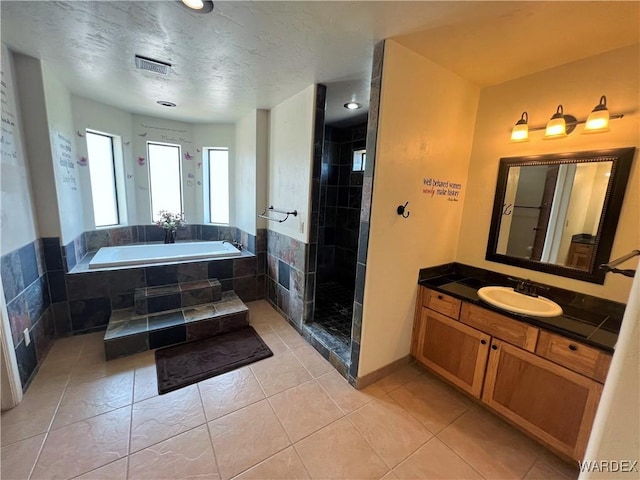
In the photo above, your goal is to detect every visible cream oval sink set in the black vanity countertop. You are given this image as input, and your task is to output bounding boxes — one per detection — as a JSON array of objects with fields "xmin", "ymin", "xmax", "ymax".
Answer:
[{"xmin": 478, "ymin": 287, "xmax": 562, "ymax": 317}]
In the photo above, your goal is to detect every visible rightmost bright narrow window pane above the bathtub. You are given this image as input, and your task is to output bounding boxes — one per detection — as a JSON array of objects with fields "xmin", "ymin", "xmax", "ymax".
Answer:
[{"xmin": 205, "ymin": 148, "xmax": 229, "ymax": 223}]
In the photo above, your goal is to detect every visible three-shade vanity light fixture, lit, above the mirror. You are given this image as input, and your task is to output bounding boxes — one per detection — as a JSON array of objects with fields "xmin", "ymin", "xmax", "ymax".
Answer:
[{"xmin": 511, "ymin": 95, "xmax": 624, "ymax": 142}]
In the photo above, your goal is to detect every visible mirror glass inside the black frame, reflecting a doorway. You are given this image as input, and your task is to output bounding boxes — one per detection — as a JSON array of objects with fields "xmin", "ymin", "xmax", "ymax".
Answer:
[{"xmin": 498, "ymin": 161, "xmax": 612, "ymax": 269}]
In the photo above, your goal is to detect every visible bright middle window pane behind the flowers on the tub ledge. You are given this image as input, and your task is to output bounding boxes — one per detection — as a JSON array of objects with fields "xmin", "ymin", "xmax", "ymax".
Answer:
[{"xmin": 147, "ymin": 142, "xmax": 183, "ymax": 222}]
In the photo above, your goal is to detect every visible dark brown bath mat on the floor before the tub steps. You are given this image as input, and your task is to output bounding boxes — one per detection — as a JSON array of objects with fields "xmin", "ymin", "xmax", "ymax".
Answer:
[{"xmin": 155, "ymin": 327, "xmax": 273, "ymax": 395}]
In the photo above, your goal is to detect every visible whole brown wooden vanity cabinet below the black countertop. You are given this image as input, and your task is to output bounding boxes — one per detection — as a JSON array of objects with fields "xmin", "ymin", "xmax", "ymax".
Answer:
[{"xmin": 412, "ymin": 287, "xmax": 611, "ymax": 460}]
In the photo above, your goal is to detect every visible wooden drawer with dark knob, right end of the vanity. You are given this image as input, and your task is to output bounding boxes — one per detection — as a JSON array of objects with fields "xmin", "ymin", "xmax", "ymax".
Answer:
[{"xmin": 536, "ymin": 331, "xmax": 611, "ymax": 383}]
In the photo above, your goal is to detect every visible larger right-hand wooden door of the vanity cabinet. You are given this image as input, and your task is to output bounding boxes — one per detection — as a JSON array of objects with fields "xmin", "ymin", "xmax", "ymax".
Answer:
[{"xmin": 482, "ymin": 339, "xmax": 602, "ymax": 460}]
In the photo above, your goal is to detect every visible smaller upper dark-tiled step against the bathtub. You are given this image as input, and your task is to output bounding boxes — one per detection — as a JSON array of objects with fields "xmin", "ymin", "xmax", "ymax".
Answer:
[{"xmin": 133, "ymin": 278, "xmax": 222, "ymax": 315}]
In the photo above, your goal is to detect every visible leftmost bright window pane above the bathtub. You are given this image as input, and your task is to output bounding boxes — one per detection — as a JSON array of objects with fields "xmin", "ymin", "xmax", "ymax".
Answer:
[{"xmin": 86, "ymin": 130, "xmax": 120, "ymax": 227}]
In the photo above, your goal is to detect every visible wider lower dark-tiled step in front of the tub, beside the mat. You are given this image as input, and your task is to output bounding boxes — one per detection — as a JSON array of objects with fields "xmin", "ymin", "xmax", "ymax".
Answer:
[{"xmin": 104, "ymin": 291, "xmax": 249, "ymax": 360}]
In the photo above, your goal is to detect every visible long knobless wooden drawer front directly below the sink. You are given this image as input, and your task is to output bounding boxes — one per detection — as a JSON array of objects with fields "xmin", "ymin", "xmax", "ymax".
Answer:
[{"xmin": 460, "ymin": 303, "xmax": 538, "ymax": 352}]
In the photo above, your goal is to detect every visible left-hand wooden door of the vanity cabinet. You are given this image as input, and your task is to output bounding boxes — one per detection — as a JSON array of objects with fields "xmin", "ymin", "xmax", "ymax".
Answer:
[{"xmin": 415, "ymin": 308, "xmax": 491, "ymax": 398}]
